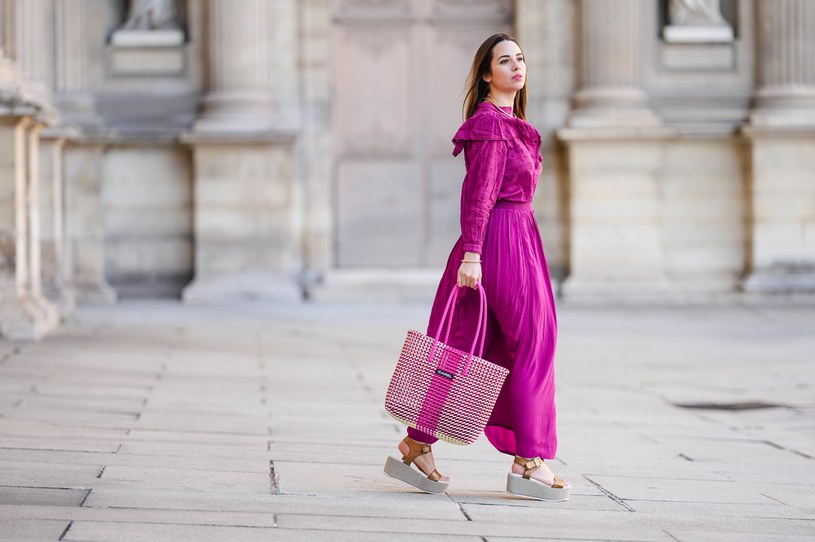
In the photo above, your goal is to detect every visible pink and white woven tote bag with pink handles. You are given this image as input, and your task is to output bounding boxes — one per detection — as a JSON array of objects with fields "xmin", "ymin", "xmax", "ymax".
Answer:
[{"xmin": 385, "ymin": 283, "xmax": 509, "ymax": 445}]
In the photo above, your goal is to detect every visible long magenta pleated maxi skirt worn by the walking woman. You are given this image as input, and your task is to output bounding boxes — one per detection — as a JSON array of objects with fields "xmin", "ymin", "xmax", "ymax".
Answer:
[{"xmin": 408, "ymin": 201, "xmax": 557, "ymax": 459}]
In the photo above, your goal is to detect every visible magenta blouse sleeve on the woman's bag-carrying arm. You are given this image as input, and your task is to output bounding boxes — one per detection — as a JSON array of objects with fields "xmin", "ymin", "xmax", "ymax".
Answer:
[{"xmin": 453, "ymin": 113, "xmax": 508, "ymax": 254}]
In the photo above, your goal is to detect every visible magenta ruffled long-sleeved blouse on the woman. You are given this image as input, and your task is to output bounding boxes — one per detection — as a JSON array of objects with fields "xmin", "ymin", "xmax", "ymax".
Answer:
[{"xmin": 453, "ymin": 102, "xmax": 543, "ymax": 254}]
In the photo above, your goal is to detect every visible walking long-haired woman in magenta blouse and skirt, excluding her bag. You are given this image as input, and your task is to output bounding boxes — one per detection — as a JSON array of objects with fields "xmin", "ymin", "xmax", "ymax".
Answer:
[{"xmin": 386, "ymin": 34, "xmax": 571, "ymax": 500}]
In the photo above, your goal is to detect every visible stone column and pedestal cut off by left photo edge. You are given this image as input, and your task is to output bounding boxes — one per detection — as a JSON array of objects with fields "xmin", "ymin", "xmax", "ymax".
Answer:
[{"xmin": 0, "ymin": 0, "xmax": 57, "ymax": 340}]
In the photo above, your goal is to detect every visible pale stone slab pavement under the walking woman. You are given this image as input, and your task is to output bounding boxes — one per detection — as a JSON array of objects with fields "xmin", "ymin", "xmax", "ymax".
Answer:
[{"xmin": 0, "ymin": 302, "xmax": 815, "ymax": 542}]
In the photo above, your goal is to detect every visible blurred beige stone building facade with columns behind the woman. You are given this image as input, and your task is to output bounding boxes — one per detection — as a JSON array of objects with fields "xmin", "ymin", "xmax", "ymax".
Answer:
[{"xmin": 0, "ymin": 0, "xmax": 815, "ymax": 339}]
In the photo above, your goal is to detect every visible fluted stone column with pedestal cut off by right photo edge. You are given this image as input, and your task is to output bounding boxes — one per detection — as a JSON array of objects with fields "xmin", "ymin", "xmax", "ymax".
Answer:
[{"xmin": 743, "ymin": 0, "xmax": 815, "ymax": 293}]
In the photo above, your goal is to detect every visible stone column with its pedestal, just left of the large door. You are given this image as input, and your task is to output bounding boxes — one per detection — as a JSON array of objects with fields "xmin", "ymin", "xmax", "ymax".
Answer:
[{"xmin": 183, "ymin": 0, "xmax": 300, "ymax": 302}]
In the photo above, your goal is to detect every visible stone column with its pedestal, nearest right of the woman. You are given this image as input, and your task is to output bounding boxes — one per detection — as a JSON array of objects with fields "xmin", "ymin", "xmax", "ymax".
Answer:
[{"xmin": 558, "ymin": 0, "xmax": 672, "ymax": 300}]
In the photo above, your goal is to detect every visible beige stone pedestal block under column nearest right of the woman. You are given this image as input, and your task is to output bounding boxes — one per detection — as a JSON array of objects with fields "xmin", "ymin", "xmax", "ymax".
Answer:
[{"xmin": 563, "ymin": 135, "xmax": 669, "ymax": 298}]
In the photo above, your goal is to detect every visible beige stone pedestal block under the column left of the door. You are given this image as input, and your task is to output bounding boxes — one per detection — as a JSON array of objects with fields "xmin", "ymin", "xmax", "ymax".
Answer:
[{"xmin": 184, "ymin": 144, "xmax": 299, "ymax": 302}]
